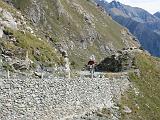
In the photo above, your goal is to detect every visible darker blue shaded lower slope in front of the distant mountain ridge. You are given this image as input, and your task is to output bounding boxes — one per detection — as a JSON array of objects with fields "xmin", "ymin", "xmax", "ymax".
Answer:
[{"xmin": 111, "ymin": 16, "xmax": 160, "ymax": 56}]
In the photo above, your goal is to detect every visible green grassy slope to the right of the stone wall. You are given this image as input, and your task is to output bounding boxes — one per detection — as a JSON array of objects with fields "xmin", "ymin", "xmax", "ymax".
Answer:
[{"xmin": 122, "ymin": 54, "xmax": 160, "ymax": 120}]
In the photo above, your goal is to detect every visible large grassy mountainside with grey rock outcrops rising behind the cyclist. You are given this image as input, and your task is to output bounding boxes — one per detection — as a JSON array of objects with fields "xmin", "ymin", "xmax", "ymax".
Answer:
[{"xmin": 1, "ymin": 0, "xmax": 139, "ymax": 68}]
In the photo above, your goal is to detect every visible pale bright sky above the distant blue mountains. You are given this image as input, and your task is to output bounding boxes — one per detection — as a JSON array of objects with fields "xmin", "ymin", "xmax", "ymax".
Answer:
[{"xmin": 106, "ymin": 0, "xmax": 160, "ymax": 14}]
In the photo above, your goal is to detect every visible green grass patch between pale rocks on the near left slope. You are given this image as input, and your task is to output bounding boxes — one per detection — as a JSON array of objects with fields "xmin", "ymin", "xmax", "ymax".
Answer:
[{"xmin": 1, "ymin": 29, "xmax": 59, "ymax": 65}]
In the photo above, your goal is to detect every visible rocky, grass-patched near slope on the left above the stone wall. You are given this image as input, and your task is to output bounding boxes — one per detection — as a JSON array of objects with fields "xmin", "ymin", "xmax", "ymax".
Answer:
[{"xmin": 0, "ymin": 1, "xmax": 59, "ymax": 70}]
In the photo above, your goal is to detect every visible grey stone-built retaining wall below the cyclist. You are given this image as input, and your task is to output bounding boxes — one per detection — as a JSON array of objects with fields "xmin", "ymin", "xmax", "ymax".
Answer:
[{"xmin": 0, "ymin": 71, "xmax": 130, "ymax": 120}]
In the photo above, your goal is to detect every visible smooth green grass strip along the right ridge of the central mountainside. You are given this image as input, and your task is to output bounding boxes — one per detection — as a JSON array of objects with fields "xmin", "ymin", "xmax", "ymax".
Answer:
[{"xmin": 78, "ymin": 0, "xmax": 124, "ymax": 49}]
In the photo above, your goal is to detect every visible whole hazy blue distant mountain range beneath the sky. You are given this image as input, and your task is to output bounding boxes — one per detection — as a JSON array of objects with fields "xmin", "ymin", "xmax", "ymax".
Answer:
[{"xmin": 96, "ymin": 0, "xmax": 160, "ymax": 56}]
